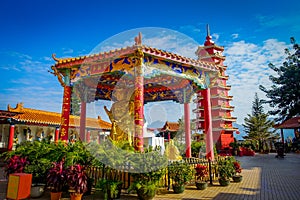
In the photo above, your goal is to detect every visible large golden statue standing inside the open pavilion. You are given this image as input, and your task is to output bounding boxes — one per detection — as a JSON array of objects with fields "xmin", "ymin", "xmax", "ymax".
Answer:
[{"xmin": 104, "ymin": 88, "xmax": 134, "ymax": 144}]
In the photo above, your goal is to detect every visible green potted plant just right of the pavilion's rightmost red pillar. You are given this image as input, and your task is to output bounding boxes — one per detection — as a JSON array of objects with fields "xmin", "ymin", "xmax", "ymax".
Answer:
[{"xmin": 217, "ymin": 157, "xmax": 235, "ymax": 186}]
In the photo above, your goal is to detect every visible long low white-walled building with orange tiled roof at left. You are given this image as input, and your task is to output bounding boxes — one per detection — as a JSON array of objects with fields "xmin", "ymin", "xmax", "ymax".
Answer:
[{"xmin": 0, "ymin": 103, "xmax": 111, "ymax": 151}]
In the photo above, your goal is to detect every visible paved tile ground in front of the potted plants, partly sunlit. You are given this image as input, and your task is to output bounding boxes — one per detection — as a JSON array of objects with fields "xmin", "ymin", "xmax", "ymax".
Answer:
[{"xmin": 0, "ymin": 153, "xmax": 300, "ymax": 200}]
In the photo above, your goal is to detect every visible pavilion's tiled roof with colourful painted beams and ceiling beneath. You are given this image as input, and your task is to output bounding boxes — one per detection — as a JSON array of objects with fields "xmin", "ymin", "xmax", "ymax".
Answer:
[{"xmin": 51, "ymin": 36, "xmax": 219, "ymax": 103}]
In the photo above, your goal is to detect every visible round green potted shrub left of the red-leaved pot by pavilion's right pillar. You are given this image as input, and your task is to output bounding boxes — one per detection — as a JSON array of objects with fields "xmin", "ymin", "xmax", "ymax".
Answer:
[{"xmin": 168, "ymin": 161, "xmax": 195, "ymax": 194}]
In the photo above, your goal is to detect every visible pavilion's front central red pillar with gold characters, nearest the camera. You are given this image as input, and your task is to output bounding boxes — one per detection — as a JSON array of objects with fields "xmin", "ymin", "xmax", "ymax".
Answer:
[{"xmin": 134, "ymin": 52, "xmax": 144, "ymax": 152}]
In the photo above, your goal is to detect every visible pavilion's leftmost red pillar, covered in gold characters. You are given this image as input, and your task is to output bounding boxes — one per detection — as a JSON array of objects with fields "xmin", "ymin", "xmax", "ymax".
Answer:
[{"xmin": 60, "ymin": 86, "xmax": 72, "ymax": 142}]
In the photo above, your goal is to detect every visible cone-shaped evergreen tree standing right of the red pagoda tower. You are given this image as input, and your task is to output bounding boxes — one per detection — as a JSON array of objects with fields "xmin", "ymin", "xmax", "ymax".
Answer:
[{"xmin": 243, "ymin": 93, "xmax": 278, "ymax": 151}]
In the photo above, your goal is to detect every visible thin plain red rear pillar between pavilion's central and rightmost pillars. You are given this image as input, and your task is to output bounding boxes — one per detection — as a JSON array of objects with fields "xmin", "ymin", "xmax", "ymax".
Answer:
[{"xmin": 184, "ymin": 103, "xmax": 192, "ymax": 158}]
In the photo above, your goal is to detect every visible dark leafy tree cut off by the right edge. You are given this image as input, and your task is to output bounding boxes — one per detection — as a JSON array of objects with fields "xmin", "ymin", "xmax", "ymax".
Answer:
[{"xmin": 259, "ymin": 37, "xmax": 300, "ymax": 122}]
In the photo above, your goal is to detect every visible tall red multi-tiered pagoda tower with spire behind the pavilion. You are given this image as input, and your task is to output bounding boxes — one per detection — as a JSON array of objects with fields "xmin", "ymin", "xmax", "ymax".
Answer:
[{"xmin": 193, "ymin": 28, "xmax": 238, "ymax": 150}]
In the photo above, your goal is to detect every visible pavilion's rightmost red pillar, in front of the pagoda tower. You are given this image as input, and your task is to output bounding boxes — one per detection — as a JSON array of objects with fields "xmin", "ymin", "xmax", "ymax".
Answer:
[{"xmin": 202, "ymin": 88, "xmax": 214, "ymax": 160}]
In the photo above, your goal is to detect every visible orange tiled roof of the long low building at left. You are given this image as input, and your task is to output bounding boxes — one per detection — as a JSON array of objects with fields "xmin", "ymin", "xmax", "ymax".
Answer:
[{"xmin": 7, "ymin": 103, "xmax": 111, "ymax": 130}]
